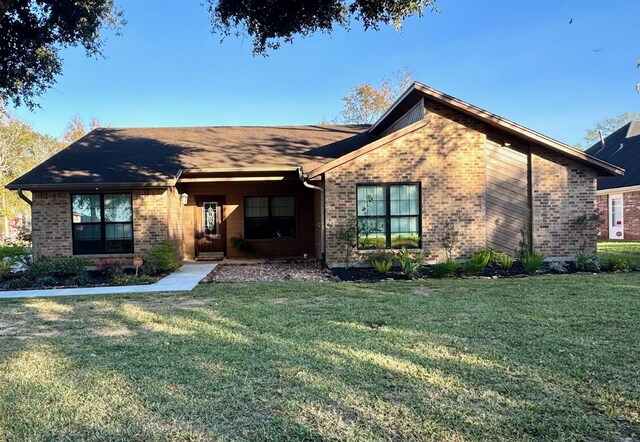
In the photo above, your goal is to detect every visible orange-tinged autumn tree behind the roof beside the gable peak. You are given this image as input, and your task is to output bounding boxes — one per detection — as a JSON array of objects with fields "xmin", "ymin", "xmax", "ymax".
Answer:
[{"xmin": 336, "ymin": 69, "xmax": 414, "ymax": 124}]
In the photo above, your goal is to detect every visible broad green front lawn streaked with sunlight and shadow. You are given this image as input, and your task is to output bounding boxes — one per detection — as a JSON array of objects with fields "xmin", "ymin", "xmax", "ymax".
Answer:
[{"xmin": 0, "ymin": 273, "xmax": 640, "ymax": 441}]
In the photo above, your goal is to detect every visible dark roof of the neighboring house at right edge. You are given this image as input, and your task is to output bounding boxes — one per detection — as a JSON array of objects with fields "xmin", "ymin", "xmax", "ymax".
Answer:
[{"xmin": 586, "ymin": 120, "xmax": 640, "ymax": 190}]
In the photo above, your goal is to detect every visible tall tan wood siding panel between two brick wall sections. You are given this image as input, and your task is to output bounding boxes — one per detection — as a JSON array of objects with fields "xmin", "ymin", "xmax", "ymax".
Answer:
[{"xmin": 486, "ymin": 141, "xmax": 530, "ymax": 256}]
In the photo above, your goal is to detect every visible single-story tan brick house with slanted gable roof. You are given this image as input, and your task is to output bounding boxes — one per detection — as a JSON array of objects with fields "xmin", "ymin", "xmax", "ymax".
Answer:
[{"xmin": 8, "ymin": 83, "xmax": 622, "ymax": 265}]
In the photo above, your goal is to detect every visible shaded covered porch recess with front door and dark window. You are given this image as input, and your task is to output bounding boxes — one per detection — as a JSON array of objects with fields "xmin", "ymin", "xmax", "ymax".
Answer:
[{"xmin": 176, "ymin": 168, "xmax": 322, "ymax": 260}]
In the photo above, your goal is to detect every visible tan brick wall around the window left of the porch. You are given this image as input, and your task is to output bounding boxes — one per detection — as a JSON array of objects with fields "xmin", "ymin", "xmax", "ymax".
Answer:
[{"xmin": 31, "ymin": 189, "xmax": 174, "ymax": 259}]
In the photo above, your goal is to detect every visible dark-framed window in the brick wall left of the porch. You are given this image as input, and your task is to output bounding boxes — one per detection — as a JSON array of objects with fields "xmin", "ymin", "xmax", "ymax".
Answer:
[{"xmin": 71, "ymin": 193, "xmax": 133, "ymax": 255}]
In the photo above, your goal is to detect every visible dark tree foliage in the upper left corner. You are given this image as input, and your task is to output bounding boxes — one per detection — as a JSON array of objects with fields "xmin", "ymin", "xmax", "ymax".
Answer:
[{"xmin": 0, "ymin": 0, "xmax": 124, "ymax": 108}]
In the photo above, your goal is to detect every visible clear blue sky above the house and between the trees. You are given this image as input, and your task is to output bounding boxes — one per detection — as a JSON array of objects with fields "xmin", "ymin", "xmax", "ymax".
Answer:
[{"xmin": 6, "ymin": 0, "xmax": 640, "ymax": 144}]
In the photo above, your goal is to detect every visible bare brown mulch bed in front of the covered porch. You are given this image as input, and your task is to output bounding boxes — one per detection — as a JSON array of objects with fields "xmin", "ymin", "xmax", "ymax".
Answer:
[{"xmin": 202, "ymin": 260, "xmax": 334, "ymax": 283}]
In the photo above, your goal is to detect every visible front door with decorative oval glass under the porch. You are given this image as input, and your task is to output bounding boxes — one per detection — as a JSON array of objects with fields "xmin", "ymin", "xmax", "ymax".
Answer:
[{"xmin": 194, "ymin": 196, "xmax": 226, "ymax": 259}]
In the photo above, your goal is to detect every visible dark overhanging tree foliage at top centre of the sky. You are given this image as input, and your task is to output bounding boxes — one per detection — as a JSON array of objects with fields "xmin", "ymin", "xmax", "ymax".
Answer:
[{"xmin": 206, "ymin": 0, "xmax": 436, "ymax": 55}]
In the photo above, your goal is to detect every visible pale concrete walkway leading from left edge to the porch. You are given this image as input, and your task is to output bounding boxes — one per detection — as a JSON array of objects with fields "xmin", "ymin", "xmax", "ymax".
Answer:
[{"xmin": 0, "ymin": 263, "xmax": 218, "ymax": 299}]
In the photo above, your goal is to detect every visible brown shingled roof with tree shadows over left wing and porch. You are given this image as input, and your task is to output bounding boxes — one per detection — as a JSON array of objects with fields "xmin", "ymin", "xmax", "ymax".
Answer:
[{"xmin": 7, "ymin": 125, "xmax": 376, "ymax": 189}]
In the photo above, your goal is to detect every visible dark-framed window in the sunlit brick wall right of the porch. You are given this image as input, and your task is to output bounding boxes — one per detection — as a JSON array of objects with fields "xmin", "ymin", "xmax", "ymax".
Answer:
[{"xmin": 356, "ymin": 183, "xmax": 421, "ymax": 249}]
